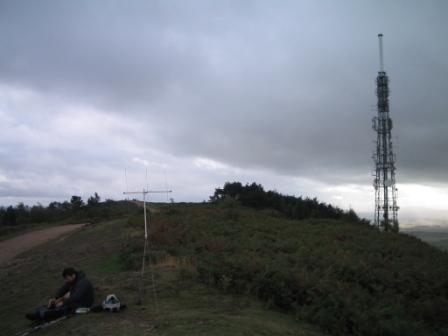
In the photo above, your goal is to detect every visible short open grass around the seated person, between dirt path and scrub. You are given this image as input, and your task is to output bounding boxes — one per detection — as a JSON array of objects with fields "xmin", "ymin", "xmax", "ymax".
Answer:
[{"xmin": 0, "ymin": 205, "xmax": 322, "ymax": 336}]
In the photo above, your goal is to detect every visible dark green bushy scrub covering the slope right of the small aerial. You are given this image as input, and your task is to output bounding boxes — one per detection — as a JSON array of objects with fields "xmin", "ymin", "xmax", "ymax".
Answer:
[{"xmin": 123, "ymin": 203, "xmax": 448, "ymax": 335}]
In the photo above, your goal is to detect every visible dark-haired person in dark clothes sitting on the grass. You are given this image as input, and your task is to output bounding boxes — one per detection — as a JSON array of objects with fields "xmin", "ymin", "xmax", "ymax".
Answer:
[{"xmin": 26, "ymin": 267, "xmax": 94, "ymax": 320}]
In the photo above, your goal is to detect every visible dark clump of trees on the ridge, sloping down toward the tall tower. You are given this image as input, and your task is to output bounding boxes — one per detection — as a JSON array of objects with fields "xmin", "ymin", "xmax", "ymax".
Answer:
[{"xmin": 210, "ymin": 182, "xmax": 370, "ymax": 224}]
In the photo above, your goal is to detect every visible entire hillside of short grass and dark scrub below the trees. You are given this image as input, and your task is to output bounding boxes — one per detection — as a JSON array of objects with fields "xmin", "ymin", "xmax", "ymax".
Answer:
[{"xmin": 0, "ymin": 202, "xmax": 448, "ymax": 336}]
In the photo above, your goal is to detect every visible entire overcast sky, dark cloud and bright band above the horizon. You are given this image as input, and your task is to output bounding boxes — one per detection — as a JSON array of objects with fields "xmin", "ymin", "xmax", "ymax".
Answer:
[{"xmin": 0, "ymin": 0, "xmax": 448, "ymax": 227}]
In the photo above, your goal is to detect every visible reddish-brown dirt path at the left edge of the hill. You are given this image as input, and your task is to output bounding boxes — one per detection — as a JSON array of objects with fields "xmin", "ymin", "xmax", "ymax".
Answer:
[{"xmin": 0, "ymin": 224, "xmax": 85, "ymax": 265}]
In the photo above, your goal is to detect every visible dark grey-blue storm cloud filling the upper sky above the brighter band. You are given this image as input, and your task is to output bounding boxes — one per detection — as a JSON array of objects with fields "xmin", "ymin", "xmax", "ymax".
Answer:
[{"xmin": 0, "ymin": 1, "xmax": 448, "ymax": 183}]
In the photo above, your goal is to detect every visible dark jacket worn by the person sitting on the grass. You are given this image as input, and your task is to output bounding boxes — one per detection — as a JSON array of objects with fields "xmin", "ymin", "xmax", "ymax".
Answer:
[{"xmin": 55, "ymin": 271, "xmax": 95, "ymax": 309}]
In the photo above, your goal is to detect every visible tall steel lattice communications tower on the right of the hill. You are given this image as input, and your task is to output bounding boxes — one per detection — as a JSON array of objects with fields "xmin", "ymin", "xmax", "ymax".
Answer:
[{"xmin": 372, "ymin": 34, "xmax": 399, "ymax": 232}]
